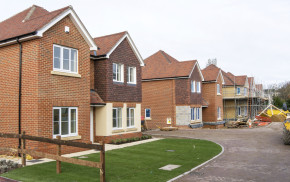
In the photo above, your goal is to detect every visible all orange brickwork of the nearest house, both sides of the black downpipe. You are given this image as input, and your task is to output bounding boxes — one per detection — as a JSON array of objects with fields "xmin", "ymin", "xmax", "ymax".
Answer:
[{"xmin": 0, "ymin": 16, "xmax": 90, "ymax": 153}]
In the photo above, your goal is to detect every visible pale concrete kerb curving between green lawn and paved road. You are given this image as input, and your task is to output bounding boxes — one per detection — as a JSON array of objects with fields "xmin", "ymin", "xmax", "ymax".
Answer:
[{"xmin": 147, "ymin": 134, "xmax": 224, "ymax": 182}]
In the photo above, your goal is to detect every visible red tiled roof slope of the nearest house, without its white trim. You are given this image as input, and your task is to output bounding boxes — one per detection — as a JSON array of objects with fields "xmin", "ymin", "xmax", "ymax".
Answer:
[{"xmin": 0, "ymin": 5, "xmax": 69, "ymax": 41}]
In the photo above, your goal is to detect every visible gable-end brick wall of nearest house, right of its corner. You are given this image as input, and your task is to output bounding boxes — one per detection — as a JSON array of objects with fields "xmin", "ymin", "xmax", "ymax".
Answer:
[{"xmin": 36, "ymin": 17, "xmax": 91, "ymax": 154}]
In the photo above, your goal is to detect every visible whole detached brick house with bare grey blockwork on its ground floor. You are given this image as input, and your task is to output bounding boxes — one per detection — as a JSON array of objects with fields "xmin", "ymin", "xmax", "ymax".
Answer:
[{"xmin": 142, "ymin": 50, "xmax": 204, "ymax": 128}]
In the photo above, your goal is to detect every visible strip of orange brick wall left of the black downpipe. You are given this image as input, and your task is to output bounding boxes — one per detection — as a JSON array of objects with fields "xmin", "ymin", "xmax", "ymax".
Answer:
[{"xmin": 0, "ymin": 44, "xmax": 19, "ymax": 150}]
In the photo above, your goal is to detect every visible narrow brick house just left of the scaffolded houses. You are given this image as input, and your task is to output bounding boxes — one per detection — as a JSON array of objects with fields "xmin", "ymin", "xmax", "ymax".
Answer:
[{"xmin": 202, "ymin": 64, "xmax": 225, "ymax": 128}]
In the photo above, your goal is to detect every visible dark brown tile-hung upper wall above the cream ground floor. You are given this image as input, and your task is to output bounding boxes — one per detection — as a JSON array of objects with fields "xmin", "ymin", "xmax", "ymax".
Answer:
[{"xmin": 95, "ymin": 39, "xmax": 142, "ymax": 102}]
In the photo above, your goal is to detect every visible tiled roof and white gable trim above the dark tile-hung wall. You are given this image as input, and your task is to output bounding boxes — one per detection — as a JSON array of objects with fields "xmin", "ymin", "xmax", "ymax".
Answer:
[{"xmin": 92, "ymin": 31, "xmax": 144, "ymax": 66}]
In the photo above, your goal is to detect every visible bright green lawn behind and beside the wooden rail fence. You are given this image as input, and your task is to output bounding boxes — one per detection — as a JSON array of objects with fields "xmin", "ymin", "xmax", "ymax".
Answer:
[{"xmin": 2, "ymin": 139, "xmax": 222, "ymax": 182}]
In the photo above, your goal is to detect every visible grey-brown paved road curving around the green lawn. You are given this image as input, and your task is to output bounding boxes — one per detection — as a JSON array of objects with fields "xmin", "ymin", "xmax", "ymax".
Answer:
[{"xmin": 148, "ymin": 123, "xmax": 290, "ymax": 182}]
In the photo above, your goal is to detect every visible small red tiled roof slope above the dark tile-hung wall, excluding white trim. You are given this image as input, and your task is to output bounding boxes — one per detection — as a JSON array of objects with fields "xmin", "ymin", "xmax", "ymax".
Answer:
[{"xmin": 94, "ymin": 31, "xmax": 127, "ymax": 56}]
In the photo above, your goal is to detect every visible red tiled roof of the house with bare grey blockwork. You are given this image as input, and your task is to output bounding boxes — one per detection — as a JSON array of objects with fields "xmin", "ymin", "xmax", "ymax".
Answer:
[{"xmin": 142, "ymin": 50, "xmax": 197, "ymax": 80}]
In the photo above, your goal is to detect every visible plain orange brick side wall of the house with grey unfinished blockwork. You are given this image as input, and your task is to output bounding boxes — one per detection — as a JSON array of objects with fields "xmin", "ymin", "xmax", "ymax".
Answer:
[{"xmin": 141, "ymin": 80, "xmax": 176, "ymax": 129}]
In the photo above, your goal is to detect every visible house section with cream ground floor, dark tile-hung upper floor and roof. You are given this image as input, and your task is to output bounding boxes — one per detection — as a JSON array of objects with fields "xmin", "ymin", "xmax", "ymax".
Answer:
[{"xmin": 91, "ymin": 32, "xmax": 144, "ymax": 143}]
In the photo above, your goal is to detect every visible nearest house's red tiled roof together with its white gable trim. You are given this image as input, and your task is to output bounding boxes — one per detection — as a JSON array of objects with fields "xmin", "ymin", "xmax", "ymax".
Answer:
[{"xmin": 0, "ymin": 5, "xmax": 97, "ymax": 50}]
